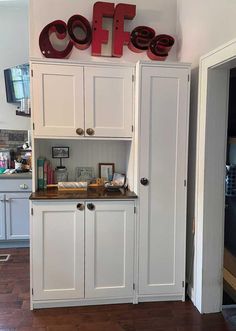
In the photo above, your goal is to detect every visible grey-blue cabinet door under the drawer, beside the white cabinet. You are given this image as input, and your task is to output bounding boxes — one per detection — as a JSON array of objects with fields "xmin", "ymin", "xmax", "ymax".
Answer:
[{"xmin": 6, "ymin": 193, "xmax": 30, "ymax": 240}]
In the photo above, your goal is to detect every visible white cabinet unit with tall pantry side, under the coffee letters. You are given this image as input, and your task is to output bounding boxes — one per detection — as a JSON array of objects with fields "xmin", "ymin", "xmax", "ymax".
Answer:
[{"xmin": 31, "ymin": 61, "xmax": 190, "ymax": 307}]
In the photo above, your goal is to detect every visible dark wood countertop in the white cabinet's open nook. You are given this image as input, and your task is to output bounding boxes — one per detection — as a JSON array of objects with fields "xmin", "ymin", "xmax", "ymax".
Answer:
[{"xmin": 30, "ymin": 188, "xmax": 138, "ymax": 200}]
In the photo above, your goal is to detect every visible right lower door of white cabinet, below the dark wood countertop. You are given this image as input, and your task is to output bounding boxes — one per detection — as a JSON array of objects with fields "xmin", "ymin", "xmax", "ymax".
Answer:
[{"xmin": 85, "ymin": 201, "xmax": 134, "ymax": 298}]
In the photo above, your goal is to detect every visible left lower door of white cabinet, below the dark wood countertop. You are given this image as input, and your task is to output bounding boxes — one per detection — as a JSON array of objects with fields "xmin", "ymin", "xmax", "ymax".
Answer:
[{"xmin": 31, "ymin": 201, "xmax": 84, "ymax": 300}]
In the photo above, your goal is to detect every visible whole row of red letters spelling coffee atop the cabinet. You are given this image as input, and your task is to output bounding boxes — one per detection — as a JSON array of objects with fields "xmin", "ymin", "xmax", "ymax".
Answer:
[{"xmin": 39, "ymin": 1, "xmax": 175, "ymax": 61}]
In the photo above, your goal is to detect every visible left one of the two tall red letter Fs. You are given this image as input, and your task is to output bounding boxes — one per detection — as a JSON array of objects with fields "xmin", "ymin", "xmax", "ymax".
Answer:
[{"xmin": 92, "ymin": 1, "xmax": 114, "ymax": 56}]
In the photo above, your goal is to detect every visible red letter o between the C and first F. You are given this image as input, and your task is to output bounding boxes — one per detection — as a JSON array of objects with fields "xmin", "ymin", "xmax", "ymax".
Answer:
[{"xmin": 67, "ymin": 15, "xmax": 92, "ymax": 49}]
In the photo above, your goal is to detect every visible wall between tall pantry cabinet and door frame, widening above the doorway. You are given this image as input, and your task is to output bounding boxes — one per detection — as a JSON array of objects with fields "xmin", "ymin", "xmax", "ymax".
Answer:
[{"xmin": 177, "ymin": 0, "xmax": 236, "ymax": 298}]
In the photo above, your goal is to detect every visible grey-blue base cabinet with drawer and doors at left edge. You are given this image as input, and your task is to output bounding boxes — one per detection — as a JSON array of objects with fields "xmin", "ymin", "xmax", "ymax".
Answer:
[{"xmin": 0, "ymin": 179, "xmax": 32, "ymax": 247}]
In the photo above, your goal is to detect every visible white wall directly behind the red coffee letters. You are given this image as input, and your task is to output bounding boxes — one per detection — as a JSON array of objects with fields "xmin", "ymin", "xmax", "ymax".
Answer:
[{"xmin": 30, "ymin": 0, "xmax": 177, "ymax": 62}]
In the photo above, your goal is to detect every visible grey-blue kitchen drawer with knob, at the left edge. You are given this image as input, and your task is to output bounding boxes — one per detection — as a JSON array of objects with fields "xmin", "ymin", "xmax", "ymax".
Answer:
[{"xmin": 0, "ymin": 178, "xmax": 32, "ymax": 192}]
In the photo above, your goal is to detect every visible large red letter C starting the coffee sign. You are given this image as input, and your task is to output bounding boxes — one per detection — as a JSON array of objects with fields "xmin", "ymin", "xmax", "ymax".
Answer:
[{"xmin": 39, "ymin": 20, "xmax": 73, "ymax": 59}]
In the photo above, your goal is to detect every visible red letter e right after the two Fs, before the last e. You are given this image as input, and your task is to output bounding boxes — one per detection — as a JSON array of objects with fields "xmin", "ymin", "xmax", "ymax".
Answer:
[{"xmin": 128, "ymin": 26, "xmax": 155, "ymax": 53}]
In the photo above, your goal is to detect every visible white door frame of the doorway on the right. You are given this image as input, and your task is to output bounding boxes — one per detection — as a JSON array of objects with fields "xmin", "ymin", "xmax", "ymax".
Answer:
[{"xmin": 193, "ymin": 39, "xmax": 236, "ymax": 313}]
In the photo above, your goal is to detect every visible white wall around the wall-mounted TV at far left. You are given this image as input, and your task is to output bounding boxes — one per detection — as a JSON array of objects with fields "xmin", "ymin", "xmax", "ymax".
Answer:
[{"xmin": 0, "ymin": 1, "xmax": 30, "ymax": 130}]
